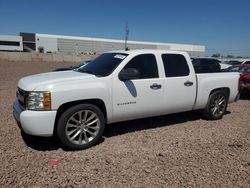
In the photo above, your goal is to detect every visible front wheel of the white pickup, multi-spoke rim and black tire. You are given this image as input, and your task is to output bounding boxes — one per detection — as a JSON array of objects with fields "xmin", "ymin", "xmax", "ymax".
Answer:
[{"xmin": 57, "ymin": 104, "xmax": 105, "ymax": 150}]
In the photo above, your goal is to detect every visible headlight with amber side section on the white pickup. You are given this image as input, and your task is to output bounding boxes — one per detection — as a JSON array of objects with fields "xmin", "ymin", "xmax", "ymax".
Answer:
[{"xmin": 28, "ymin": 91, "xmax": 51, "ymax": 111}]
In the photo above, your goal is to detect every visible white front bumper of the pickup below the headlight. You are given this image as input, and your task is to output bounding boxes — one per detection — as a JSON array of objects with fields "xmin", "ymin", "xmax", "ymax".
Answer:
[{"xmin": 13, "ymin": 100, "xmax": 56, "ymax": 137}]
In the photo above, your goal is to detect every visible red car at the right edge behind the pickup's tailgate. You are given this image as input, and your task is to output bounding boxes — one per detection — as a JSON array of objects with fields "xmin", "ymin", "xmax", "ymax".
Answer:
[{"xmin": 224, "ymin": 64, "xmax": 250, "ymax": 91}]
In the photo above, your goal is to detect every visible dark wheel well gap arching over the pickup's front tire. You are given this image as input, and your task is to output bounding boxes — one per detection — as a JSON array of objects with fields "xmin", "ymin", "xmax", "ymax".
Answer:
[{"xmin": 53, "ymin": 99, "xmax": 107, "ymax": 135}]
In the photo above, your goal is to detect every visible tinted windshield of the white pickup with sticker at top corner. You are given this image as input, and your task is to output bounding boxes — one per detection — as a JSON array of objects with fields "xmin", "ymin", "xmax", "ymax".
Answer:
[{"xmin": 77, "ymin": 53, "xmax": 128, "ymax": 77}]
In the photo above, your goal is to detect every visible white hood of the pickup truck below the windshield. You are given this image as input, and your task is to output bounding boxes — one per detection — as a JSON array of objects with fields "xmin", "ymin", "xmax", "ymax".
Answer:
[{"xmin": 18, "ymin": 71, "xmax": 95, "ymax": 91}]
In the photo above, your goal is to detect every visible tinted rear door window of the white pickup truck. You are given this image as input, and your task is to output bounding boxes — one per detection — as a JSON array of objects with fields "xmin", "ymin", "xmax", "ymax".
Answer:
[{"xmin": 161, "ymin": 54, "xmax": 189, "ymax": 77}]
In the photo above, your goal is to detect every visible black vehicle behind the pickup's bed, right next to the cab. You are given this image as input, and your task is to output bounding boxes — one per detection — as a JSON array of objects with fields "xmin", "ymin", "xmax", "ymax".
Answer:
[{"xmin": 191, "ymin": 58, "xmax": 221, "ymax": 73}]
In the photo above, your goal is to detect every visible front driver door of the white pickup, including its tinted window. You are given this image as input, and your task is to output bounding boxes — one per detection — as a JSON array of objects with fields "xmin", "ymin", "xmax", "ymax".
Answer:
[{"xmin": 113, "ymin": 54, "xmax": 163, "ymax": 122}]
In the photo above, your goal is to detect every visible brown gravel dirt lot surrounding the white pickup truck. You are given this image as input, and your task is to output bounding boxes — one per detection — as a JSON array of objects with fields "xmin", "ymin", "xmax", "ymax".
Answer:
[{"xmin": 0, "ymin": 61, "xmax": 250, "ymax": 187}]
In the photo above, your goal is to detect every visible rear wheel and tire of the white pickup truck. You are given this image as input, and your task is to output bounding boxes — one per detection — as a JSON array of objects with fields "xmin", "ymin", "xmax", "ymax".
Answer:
[{"xmin": 201, "ymin": 90, "xmax": 228, "ymax": 120}]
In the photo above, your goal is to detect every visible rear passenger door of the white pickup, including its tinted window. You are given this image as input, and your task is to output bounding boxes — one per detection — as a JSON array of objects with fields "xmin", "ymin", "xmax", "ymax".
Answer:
[{"xmin": 161, "ymin": 54, "xmax": 196, "ymax": 113}]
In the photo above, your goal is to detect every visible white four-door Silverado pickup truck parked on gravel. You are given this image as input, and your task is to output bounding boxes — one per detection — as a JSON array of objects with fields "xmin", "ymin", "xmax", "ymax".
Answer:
[{"xmin": 13, "ymin": 50, "xmax": 239, "ymax": 150}]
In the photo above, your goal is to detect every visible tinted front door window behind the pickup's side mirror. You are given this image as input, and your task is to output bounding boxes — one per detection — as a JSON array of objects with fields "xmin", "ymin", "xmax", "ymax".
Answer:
[{"xmin": 124, "ymin": 54, "xmax": 159, "ymax": 79}]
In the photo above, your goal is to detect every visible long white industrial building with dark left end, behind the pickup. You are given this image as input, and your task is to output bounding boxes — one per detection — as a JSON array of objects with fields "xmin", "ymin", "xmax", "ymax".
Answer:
[{"xmin": 0, "ymin": 32, "xmax": 205, "ymax": 56}]
